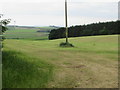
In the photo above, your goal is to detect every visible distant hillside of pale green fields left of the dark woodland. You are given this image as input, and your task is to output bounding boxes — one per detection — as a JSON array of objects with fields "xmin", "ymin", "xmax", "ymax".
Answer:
[{"xmin": 4, "ymin": 25, "xmax": 58, "ymax": 40}]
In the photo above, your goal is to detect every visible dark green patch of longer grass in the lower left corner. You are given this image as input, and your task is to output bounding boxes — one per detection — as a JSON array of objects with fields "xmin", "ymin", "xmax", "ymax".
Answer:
[{"xmin": 2, "ymin": 51, "xmax": 53, "ymax": 88}]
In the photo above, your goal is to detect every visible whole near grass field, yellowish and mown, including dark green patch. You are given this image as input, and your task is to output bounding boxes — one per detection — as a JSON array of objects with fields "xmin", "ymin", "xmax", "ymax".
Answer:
[{"xmin": 2, "ymin": 35, "xmax": 118, "ymax": 88}]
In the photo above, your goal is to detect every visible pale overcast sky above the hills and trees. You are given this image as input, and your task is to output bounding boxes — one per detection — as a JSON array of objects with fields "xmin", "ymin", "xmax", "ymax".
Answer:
[{"xmin": 0, "ymin": 0, "xmax": 118, "ymax": 26}]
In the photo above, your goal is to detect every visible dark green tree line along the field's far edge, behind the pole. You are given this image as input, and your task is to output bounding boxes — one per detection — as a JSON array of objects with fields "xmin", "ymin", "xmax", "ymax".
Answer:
[{"xmin": 49, "ymin": 20, "xmax": 120, "ymax": 40}]
